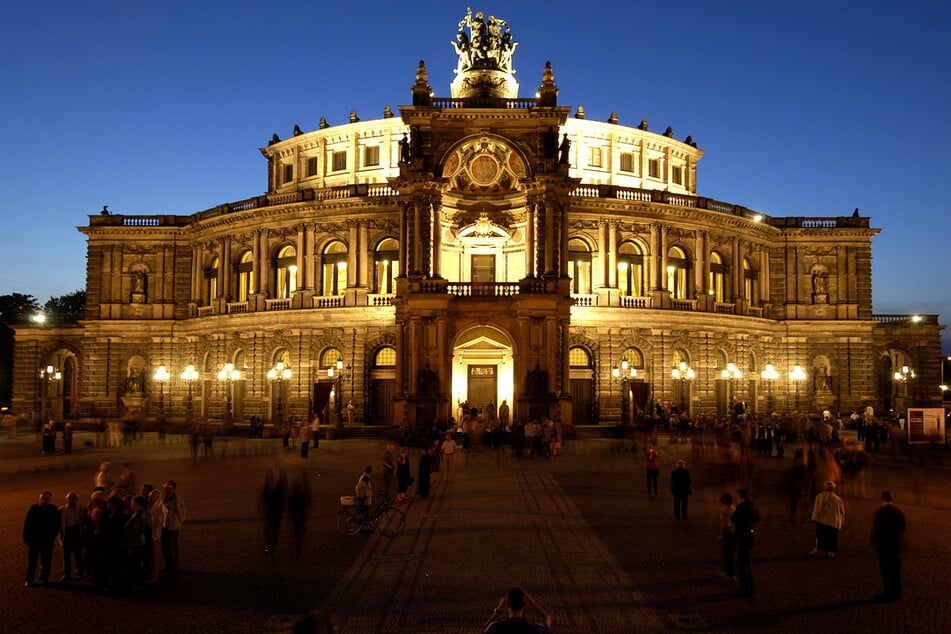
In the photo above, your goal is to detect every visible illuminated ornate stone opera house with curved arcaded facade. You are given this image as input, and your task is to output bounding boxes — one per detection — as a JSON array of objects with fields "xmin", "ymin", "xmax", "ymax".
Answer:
[{"xmin": 14, "ymin": 13, "xmax": 941, "ymax": 428}]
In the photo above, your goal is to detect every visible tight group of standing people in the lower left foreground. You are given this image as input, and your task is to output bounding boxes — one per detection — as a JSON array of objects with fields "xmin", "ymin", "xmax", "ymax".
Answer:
[{"xmin": 23, "ymin": 462, "xmax": 187, "ymax": 592}]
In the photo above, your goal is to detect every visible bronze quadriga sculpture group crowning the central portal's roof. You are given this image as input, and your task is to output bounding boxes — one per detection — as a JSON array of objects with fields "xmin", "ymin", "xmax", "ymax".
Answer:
[{"xmin": 452, "ymin": 7, "xmax": 518, "ymax": 73}]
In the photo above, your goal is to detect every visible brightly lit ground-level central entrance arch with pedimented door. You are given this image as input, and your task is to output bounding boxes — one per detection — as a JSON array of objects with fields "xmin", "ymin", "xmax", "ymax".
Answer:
[{"xmin": 450, "ymin": 325, "xmax": 515, "ymax": 421}]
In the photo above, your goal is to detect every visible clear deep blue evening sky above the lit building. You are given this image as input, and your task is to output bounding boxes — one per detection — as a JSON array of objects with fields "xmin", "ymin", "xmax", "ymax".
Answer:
[{"xmin": 0, "ymin": 0, "xmax": 951, "ymax": 353}]
